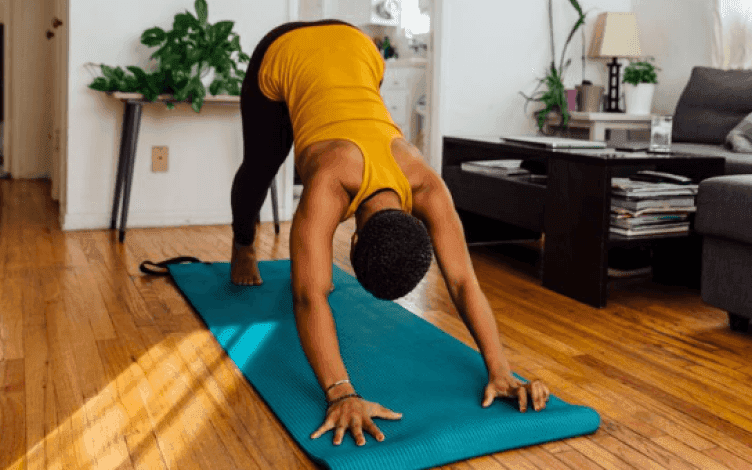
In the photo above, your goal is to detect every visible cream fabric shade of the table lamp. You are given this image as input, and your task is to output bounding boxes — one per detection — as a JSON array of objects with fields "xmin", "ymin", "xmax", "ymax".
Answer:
[{"xmin": 588, "ymin": 13, "xmax": 642, "ymax": 59}]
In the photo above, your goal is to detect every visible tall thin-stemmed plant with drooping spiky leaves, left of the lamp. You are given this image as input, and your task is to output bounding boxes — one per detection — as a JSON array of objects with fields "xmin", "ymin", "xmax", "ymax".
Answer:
[{"xmin": 520, "ymin": 0, "xmax": 587, "ymax": 131}]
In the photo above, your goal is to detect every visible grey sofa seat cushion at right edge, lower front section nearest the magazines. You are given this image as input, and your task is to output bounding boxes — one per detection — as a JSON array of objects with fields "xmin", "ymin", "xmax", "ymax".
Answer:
[{"xmin": 695, "ymin": 175, "xmax": 752, "ymax": 244}]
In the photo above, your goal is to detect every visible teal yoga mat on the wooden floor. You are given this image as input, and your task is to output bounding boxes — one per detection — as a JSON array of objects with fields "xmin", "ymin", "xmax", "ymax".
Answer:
[{"xmin": 169, "ymin": 260, "xmax": 600, "ymax": 470}]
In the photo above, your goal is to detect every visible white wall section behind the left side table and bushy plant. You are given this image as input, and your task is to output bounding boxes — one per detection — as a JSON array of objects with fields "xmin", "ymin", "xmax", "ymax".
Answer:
[{"xmin": 63, "ymin": 0, "xmax": 292, "ymax": 230}]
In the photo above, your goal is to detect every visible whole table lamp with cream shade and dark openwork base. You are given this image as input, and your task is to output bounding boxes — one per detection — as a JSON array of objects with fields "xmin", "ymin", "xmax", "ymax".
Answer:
[{"xmin": 588, "ymin": 13, "xmax": 642, "ymax": 113}]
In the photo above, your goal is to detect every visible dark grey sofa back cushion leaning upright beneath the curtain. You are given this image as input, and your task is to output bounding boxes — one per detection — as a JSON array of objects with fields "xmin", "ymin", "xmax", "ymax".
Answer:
[{"xmin": 672, "ymin": 67, "xmax": 752, "ymax": 145}]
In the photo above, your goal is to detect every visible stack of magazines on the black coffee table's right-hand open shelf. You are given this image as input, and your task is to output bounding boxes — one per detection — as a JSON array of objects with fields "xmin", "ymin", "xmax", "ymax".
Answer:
[{"xmin": 610, "ymin": 178, "xmax": 697, "ymax": 237}]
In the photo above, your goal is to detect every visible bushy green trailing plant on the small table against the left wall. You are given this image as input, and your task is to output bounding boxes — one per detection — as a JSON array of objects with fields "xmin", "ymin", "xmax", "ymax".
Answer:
[{"xmin": 89, "ymin": 0, "xmax": 251, "ymax": 113}]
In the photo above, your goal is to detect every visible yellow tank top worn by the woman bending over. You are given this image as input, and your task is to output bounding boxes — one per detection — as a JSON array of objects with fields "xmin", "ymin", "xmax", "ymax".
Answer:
[{"xmin": 258, "ymin": 25, "xmax": 412, "ymax": 219}]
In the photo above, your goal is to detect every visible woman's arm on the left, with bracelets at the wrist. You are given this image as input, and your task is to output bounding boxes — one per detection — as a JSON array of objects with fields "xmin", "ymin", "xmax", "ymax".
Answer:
[{"xmin": 290, "ymin": 173, "xmax": 401, "ymax": 445}]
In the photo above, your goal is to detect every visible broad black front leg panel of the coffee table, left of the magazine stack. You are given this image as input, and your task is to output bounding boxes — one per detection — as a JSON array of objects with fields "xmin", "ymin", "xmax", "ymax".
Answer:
[{"xmin": 543, "ymin": 160, "xmax": 611, "ymax": 308}]
